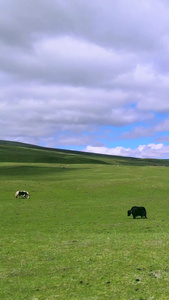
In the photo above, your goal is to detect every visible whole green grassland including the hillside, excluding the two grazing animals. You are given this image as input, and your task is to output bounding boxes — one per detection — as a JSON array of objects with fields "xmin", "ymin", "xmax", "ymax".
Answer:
[{"xmin": 0, "ymin": 143, "xmax": 169, "ymax": 300}]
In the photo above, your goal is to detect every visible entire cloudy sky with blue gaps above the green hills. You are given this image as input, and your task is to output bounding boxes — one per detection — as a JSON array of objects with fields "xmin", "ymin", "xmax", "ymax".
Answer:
[{"xmin": 0, "ymin": 0, "xmax": 169, "ymax": 158}]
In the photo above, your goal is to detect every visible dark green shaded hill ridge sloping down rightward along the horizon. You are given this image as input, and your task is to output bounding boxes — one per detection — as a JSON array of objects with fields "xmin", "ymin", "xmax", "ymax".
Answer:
[{"xmin": 0, "ymin": 140, "xmax": 169, "ymax": 167}]
